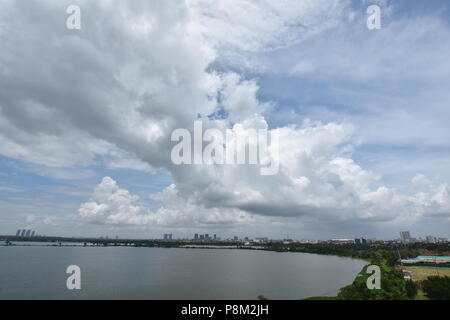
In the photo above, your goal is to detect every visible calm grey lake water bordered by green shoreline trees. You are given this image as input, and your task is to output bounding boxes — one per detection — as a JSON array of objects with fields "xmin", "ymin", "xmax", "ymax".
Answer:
[{"xmin": 0, "ymin": 247, "xmax": 365, "ymax": 300}]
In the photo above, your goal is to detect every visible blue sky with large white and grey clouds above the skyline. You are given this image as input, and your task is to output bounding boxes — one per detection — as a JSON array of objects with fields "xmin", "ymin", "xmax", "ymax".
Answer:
[{"xmin": 0, "ymin": 0, "xmax": 450, "ymax": 239}]
